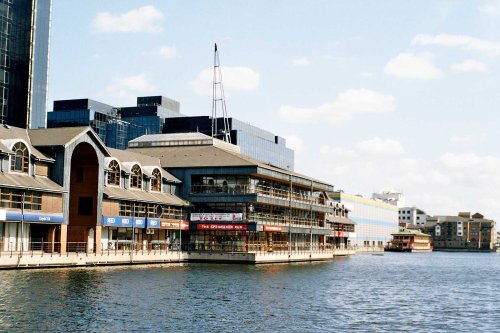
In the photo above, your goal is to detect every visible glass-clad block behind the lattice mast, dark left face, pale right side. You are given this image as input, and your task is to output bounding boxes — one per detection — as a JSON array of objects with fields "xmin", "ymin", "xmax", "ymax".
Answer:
[{"xmin": 163, "ymin": 116, "xmax": 294, "ymax": 171}]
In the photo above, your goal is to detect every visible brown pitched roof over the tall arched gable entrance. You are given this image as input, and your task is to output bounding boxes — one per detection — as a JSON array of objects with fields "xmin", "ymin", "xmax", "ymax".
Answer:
[{"xmin": 28, "ymin": 126, "xmax": 109, "ymax": 155}]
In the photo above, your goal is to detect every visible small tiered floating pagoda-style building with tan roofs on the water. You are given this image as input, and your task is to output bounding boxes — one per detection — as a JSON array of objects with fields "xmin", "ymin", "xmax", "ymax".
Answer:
[{"xmin": 384, "ymin": 229, "xmax": 432, "ymax": 252}]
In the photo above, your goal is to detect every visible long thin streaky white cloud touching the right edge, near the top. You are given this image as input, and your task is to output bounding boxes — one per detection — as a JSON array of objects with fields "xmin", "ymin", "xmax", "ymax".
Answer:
[{"xmin": 411, "ymin": 34, "xmax": 500, "ymax": 55}]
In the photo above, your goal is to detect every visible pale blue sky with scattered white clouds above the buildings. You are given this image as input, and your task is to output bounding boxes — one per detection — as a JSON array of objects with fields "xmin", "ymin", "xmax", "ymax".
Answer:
[{"xmin": 49, "ymin": 0, "xmax": 500, "ymax": 221}]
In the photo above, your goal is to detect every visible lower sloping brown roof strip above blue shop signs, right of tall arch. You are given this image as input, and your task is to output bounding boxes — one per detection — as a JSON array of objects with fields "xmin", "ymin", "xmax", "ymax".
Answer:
[{"xmin": 104, "ymin": 186, "xmax": 189, "ymax": 206}]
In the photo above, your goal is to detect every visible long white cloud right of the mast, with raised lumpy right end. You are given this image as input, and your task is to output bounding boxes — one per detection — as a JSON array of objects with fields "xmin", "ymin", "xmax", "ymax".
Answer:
[{"xmin": 278, "ymin": 89, "xmax": 396, "ymax": 124}]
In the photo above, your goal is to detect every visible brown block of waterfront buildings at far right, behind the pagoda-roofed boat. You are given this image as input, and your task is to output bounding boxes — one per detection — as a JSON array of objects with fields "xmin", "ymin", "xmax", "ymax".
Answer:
[{"xmin": 425, "ymin": 212, "xmax": 496, "ymax": 251}]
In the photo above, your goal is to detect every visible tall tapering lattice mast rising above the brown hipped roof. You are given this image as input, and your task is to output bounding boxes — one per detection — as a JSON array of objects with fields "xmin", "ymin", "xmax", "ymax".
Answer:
[{"xmin": 212, "ymin": 43, "xmax": 231, "ymax": 143}]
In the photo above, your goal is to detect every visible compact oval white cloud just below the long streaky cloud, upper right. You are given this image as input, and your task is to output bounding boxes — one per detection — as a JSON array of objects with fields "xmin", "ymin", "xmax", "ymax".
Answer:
[{"xmin": 384, "ymin": 53, "xmax": 441, "ymax": 80}]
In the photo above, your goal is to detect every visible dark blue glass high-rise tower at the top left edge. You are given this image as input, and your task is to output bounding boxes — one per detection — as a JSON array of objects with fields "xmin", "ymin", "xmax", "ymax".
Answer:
[{"xmin": 0, "ymin": 0, "xmax": 51, "ymax": 128}]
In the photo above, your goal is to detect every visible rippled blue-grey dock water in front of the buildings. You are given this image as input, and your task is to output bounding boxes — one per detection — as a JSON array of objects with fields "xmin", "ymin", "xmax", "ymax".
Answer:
[{"xmin": 0, "ymin": 253, "xmax": 500, "ymax": 332}]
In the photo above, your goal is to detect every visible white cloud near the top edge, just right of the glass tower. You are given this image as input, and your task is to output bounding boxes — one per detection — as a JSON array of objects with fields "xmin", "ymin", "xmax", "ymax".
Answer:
[{"xmin": 92, "ymin": 6, "xmax": 163, "ymax": 33}]
